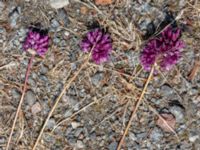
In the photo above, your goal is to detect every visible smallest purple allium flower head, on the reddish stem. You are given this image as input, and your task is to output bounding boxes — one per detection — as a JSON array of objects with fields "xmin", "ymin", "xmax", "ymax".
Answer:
[{"xmin": 23, "ymin": 28, "xmax": 49, "ymax": 57}]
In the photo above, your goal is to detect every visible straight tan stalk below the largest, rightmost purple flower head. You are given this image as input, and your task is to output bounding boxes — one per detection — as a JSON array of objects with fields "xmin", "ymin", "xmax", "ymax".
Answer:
[{"xmin": 117, "ymin": 65, "xmax": 155, "ymax": 150}]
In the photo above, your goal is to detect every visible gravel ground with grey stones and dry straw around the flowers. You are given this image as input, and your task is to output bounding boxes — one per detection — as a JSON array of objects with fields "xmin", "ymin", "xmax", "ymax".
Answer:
[{"xmin": 0, "ymin": 0, "xmax": 200, "ymax": 150}]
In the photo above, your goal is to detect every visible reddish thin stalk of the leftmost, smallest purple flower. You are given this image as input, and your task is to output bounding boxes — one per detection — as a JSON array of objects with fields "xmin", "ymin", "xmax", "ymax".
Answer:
[{"xmin": 6, "ymin": 55, "xmax": 35, "ymax": 150}]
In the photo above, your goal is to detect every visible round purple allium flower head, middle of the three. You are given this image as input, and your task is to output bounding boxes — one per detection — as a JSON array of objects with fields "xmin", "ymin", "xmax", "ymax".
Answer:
[{"xmin": 80, "ymin": 29, "xmax": 112, "ymax": 64}]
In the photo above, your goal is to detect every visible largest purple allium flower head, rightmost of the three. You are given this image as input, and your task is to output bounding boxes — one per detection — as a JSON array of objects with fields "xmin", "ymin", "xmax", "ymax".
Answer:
[{"xmin": 140, "ymin": 26, "xmax": 185, "ymax": 71}]
